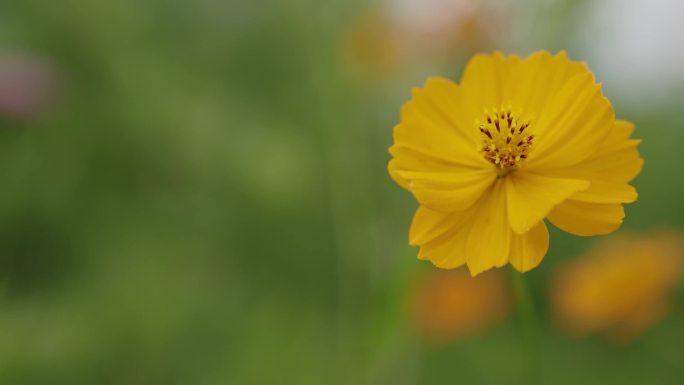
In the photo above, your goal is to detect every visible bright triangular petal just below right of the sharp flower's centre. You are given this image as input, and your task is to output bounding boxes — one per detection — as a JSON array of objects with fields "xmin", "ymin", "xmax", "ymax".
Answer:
[{"xmin": 505, "ymin": 172, "xmax": 589, "ymax": 234}]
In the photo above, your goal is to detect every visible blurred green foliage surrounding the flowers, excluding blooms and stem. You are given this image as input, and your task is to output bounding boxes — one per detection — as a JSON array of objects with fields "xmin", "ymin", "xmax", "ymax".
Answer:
[{"xmin": 0, "ymin": 0, "xmax": 684, "ymax": 385}]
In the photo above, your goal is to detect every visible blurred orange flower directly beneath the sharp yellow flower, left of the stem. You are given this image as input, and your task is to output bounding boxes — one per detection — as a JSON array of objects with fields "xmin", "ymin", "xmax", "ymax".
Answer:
[{"xmin": 411, "ymin": 270, "xmax": 510, "ymax": 344}]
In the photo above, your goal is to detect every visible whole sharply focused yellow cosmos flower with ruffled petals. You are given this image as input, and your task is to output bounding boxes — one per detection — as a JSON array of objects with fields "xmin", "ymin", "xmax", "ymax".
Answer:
[{"xmin": 389, "ymin": 52, "xmax": 643, "ymax": 275}]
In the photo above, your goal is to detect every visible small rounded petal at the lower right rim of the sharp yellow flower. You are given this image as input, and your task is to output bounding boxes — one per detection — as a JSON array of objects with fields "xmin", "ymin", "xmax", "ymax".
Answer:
[{"xmin": 548, "ymin": 199, "xmax": 625, "ymax": 236}]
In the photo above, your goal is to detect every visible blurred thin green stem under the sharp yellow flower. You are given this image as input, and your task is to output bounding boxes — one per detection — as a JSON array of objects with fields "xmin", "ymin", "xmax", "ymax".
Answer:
[{"xmin": 511, "ymin": 270, "xmax": 541, "ymax": 385}]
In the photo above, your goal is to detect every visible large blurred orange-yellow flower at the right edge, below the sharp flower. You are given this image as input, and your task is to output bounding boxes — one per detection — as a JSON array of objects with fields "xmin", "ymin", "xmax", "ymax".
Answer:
[{"xmin": 551, "ymin": 232, "xmax": 684, "ymax": 342}]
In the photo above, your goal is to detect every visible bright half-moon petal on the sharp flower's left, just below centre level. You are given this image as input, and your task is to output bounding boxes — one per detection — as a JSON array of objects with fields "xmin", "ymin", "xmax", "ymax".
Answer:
[{"xmin": 397, "ymin": 169, "xmax": 496, "ymax": 212}]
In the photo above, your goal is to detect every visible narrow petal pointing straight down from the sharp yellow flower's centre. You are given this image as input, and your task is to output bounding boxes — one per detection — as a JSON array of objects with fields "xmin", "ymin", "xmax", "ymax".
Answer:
[{"xmin": 466, "ymin": 179, "xmax": 511, "ymax": 276}]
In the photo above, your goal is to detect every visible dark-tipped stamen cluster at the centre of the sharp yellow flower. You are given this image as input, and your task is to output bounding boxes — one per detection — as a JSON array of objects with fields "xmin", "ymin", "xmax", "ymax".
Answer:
[{"xmin": 477, "ymin": 106, "xmax": 534, "ymax": 176}]
